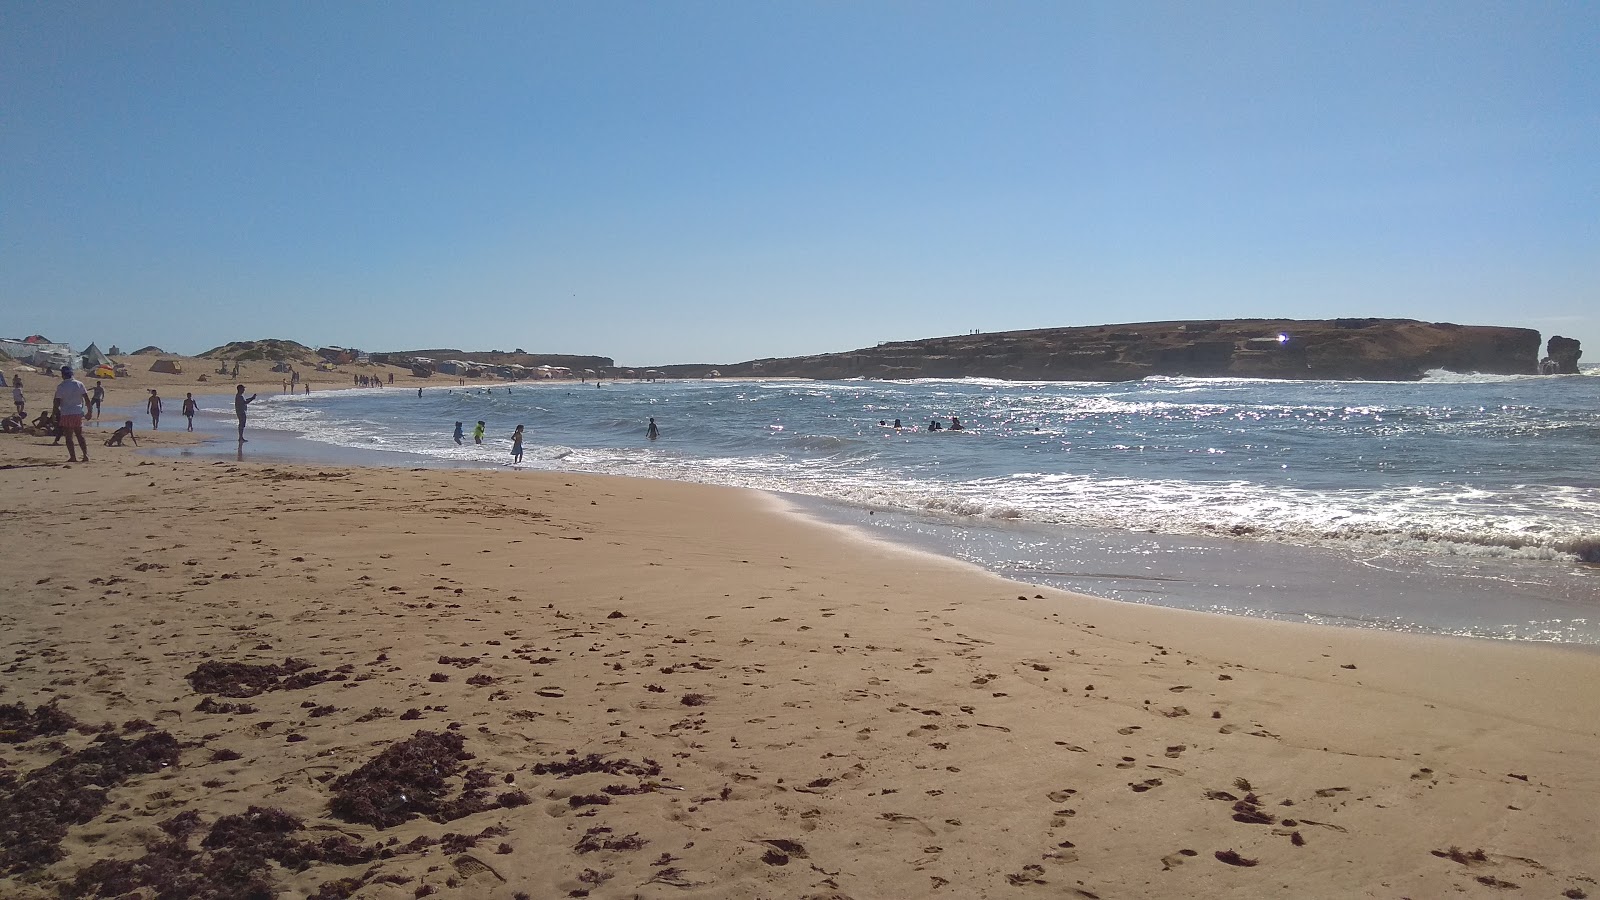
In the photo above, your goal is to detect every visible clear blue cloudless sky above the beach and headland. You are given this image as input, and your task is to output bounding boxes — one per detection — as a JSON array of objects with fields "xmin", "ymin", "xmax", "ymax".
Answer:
[{"xmin": 0, "ymin": 0, "xmax": 1600, "ymax": 365}]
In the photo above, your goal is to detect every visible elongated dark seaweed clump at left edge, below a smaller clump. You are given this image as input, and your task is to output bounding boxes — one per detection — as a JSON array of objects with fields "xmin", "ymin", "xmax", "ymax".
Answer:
[{"xmin": 0, "ymin": 732, "xmax": 178, "ymax": 874}]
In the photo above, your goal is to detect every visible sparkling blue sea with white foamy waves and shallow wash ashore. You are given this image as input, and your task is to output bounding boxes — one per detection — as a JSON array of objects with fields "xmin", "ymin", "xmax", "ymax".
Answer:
[{"xmin": 175, "ymin": 372, "xmax": 1600, "ymax": 644}]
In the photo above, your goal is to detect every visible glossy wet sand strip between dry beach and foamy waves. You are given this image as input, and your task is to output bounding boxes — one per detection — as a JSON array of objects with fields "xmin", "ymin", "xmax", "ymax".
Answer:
[{"xmin": 140, "ymin": 392, "xmax": 1600, "ymax": 647}]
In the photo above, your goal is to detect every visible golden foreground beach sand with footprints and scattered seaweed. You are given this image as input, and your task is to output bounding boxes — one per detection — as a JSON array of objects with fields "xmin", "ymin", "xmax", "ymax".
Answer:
[{"xmin": 0, "ymin": 422, "xmax": 1600, "ymax": 900}]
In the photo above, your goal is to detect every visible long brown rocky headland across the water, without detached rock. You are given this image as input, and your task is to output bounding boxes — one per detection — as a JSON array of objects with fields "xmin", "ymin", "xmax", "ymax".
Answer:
[{"xmin": 694, "ymin": 319, "xmax": 1541, "ymax": 381}]
